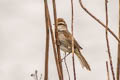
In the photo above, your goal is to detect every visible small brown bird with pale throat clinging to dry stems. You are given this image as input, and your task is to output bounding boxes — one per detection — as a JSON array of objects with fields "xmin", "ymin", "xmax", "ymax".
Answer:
[{"xmin": 57, "ymin": 18, "xmax": 91, "ymax": 71}]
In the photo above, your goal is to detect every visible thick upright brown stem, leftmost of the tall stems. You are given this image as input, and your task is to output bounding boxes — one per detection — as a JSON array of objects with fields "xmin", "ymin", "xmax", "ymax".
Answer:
[{"xmin": 44, "ymin": 0, "xmax": 49, "ymax": 80}]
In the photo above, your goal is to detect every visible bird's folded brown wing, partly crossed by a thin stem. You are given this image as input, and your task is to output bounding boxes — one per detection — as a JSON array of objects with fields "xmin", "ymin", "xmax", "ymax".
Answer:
[{"xmin": 64, "ymin": 31, "xmax": 83, "ymax": 49}]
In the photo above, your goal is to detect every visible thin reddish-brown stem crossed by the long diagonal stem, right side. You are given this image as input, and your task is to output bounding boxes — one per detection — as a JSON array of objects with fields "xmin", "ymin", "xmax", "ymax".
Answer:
[{"xmin": 105, "ymin": 0, "xmax": 115, "ymax": 80}]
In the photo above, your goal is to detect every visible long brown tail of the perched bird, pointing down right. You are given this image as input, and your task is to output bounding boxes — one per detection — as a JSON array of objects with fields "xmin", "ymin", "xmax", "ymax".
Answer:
[{"xmin": 75, "ymin": 51, "xmax": 91, "ymax": 71}]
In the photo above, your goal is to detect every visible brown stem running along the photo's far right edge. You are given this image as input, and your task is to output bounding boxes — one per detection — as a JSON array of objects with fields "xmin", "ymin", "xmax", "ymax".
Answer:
[{"xmin": 117, "ymin": 0, "xmax": 120, "ymax": 80}]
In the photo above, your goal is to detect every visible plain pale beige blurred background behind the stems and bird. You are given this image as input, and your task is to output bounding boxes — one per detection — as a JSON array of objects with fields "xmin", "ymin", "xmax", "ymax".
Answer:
[{"xmin": 0, "ymin": 0, "xmax": 118, "ymax": 80}]
